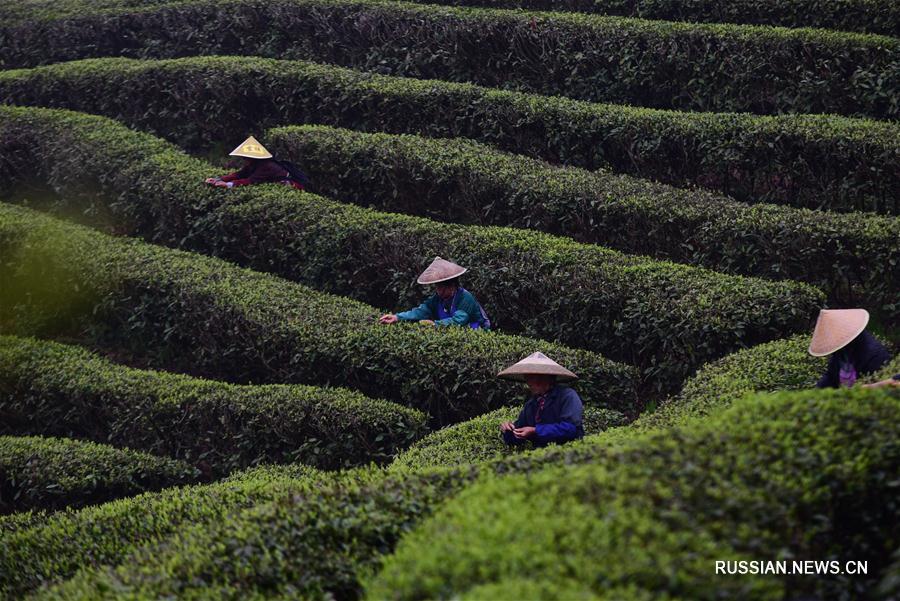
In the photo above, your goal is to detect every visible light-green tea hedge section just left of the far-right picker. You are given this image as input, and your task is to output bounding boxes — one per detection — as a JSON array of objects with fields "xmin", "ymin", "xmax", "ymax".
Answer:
[{"xmin": 634, "ymin": 334, "xmax": 828, "ymax": 428}]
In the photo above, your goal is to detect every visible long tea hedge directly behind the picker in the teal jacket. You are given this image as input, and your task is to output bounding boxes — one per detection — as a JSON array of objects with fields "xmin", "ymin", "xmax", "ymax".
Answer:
[{"xmin": 0, "ymin": 108, "xmax": 823, "ymax": 394}]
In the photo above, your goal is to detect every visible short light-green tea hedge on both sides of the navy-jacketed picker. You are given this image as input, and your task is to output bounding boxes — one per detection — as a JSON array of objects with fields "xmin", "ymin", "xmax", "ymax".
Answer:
[{"xmin": 387, "ymin": 406, "xmax": 627, "ymax": 473}]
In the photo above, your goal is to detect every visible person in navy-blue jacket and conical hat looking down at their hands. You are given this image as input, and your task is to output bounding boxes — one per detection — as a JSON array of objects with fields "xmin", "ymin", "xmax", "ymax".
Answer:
[{"xmin": 497, "ymin": 353, "xmax": 584, "ymax": 447}]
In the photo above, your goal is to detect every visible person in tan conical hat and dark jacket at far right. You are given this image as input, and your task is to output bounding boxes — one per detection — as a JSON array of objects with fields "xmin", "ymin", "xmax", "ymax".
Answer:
[{"xmin": 809, "ymin": 309, "xmax": 891, "ymax": 388}]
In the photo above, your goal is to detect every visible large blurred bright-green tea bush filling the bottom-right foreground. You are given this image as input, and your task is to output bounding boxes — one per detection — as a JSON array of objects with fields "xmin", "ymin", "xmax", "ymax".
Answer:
[{"xmin": 366, "ymin": 389, "xmax": 900, "ymax": 599}]
